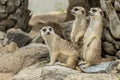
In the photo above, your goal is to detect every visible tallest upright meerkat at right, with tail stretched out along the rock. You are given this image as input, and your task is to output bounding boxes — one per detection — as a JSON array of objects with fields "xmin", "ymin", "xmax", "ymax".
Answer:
[{"xmin": 82, "ymin": 8, "xmax": 112, "ymax": 67}]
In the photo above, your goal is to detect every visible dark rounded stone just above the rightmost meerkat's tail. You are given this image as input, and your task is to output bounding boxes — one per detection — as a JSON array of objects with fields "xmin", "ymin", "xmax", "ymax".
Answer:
[{"xmin": 103, "ymin": 42, "xmax": 116, "ymax": 55}]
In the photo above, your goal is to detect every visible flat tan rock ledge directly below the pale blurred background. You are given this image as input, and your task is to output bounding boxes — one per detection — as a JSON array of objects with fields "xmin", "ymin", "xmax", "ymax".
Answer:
[{"xmin": 29, "ymin": 12, "xmax": 66, "ymax": 25}]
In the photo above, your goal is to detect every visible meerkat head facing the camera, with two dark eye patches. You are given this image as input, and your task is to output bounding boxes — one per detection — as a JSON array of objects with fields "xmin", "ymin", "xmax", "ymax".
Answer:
[{"xmin": 40, "ymin": 26, "xmax": 54, "ymax": 36}]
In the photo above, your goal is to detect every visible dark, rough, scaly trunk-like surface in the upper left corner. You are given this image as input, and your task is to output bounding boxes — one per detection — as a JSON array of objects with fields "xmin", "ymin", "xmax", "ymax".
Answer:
[{"xmin": 0, "ymin": 0, "xmax": 29, "ymax": 32}]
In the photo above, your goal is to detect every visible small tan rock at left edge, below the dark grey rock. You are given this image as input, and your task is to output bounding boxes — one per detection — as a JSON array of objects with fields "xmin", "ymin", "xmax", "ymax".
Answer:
[{"xmin": 0, "ymin": 42, "xmax": 18, "ymax": 53}]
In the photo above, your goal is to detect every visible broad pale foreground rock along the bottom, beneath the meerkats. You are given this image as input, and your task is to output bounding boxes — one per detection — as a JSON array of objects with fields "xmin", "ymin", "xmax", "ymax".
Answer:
[{"xmin": 12, "ymin": 63, "xmax": 119, "ymax": 80}]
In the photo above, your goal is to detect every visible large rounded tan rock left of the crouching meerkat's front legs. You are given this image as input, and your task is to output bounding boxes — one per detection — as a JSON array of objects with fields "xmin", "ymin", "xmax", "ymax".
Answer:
[{"xmin": 0, "ymin": 43, "xmax": 49, "ymax": 73}]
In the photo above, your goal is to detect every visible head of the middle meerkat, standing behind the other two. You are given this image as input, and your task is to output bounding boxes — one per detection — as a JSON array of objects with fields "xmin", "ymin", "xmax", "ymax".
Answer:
[{"xmin": 70, "ymin": 7, "xmax": 86, "ymax": 16}]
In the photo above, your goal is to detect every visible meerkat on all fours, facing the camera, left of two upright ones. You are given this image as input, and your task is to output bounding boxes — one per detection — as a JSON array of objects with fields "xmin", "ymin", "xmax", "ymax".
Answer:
[{"xmin": 40, "ymin": 26, "xmax": 80, "ymax": 70}]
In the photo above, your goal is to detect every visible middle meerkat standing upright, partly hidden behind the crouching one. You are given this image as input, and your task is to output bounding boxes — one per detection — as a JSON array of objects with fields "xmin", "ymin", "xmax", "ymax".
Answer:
[{"xmin": 70, "ymin": 7, "xmax": 87, "ymax": 43}]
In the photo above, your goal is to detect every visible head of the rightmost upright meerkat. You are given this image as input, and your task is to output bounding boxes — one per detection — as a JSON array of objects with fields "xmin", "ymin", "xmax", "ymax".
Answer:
[{"xmin": 88, "ymin": 8, "xmax": 103, "ymax": 17}]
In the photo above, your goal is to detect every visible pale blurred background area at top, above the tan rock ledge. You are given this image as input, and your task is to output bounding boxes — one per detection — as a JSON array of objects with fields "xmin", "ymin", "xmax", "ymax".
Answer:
[{"xmin": 29, "ymin": 0, "xmax": 68, "ymax": 14}]
